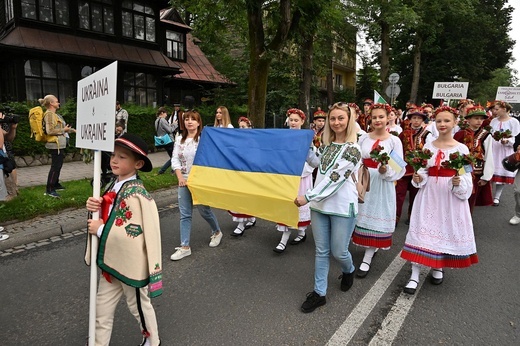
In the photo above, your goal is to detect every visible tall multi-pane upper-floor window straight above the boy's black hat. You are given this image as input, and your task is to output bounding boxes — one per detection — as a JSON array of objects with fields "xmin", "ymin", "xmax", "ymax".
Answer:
[{"xmin": 122, "ymin": 0, "xmax": 155, "ymax": 42}]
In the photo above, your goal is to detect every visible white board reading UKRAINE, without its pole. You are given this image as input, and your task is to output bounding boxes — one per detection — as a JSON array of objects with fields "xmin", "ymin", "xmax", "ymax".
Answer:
[{"xmin": 76, "ymin": 61, "xmax": 117, "ymax": 152}]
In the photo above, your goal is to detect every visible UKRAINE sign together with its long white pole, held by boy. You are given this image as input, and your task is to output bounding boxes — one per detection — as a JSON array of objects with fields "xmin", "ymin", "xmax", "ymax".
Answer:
[{"xmin": 76, "ymin": 61, "xmax": 117, "ymax": 345}]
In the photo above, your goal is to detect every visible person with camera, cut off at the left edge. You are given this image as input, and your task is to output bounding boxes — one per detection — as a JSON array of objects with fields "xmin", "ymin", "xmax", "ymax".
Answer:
[{"xmin": 0, "ymin": 108, "xmax": 19, "ymax": 201}]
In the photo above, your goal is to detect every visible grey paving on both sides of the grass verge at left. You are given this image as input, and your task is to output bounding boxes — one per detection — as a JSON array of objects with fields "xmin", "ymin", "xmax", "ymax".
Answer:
[{"xmin": 0, "ymin": 151, "xmax": 177, "ymax": 251}]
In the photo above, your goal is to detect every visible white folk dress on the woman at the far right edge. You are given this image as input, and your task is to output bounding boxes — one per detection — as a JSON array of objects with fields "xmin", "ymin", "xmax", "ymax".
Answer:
[{"xmin": 490, "ymin": 118, "xmax": 520, "ymax": 184}]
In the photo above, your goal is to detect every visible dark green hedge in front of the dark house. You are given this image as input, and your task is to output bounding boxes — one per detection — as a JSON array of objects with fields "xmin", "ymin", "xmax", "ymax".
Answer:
[{"xmin": 0, "ymin": 99, "xmax": 247, "ymax": 156}]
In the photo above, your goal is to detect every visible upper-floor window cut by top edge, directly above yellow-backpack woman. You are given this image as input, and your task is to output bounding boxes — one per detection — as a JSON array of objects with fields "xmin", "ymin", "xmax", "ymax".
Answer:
[{"xmin": 21, "ymin": 0, "xmax": 69, "ymax": 25}]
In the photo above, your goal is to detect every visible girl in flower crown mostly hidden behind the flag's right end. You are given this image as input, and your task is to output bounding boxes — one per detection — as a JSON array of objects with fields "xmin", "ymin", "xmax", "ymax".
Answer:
[{"xmin": 273, "ymin": 108, "xmax": 314, "ymax": 253}]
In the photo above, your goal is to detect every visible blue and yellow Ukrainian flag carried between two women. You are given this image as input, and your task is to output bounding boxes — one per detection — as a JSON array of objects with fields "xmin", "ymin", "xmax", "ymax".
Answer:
[{"xmin": 188, "ymin": 127, "xmax": 314, "ymax": 226}]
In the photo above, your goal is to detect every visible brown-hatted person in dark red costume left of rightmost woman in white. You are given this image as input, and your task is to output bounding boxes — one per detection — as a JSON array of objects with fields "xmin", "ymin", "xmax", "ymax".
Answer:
[{"xmin": 453, "ymin": 105, "xmax": 495, "ymax": 213}]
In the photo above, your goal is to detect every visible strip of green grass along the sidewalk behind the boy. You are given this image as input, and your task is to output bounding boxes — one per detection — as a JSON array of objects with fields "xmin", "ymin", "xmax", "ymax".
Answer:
[{"xmin": 0, "ymin": 168, "xmax": 177, "ymax": 222}]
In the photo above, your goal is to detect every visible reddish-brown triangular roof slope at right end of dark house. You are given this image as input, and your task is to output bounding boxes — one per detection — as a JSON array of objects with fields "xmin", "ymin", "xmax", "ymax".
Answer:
[{"xmin": 173, "ymin": 34, "xmax": 233, "ymax": 84}]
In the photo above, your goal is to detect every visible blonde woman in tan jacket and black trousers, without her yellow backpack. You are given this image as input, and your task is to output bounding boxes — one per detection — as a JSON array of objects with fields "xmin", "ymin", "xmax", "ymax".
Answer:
[{"xmin": 38, "ymin": 95, "xmax": 76, "ymax": 198}]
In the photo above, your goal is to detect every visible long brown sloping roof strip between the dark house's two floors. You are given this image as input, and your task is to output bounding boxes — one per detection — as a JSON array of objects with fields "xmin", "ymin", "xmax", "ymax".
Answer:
[{"xmin": 0, "ymin": 27, "xmax": 180, "ymax": 74}]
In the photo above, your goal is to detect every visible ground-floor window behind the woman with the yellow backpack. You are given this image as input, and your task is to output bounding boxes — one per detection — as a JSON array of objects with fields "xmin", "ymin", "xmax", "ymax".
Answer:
[{"xmin": 24, "ymin": 60, "xmax": 76, "ymax": 102}]
